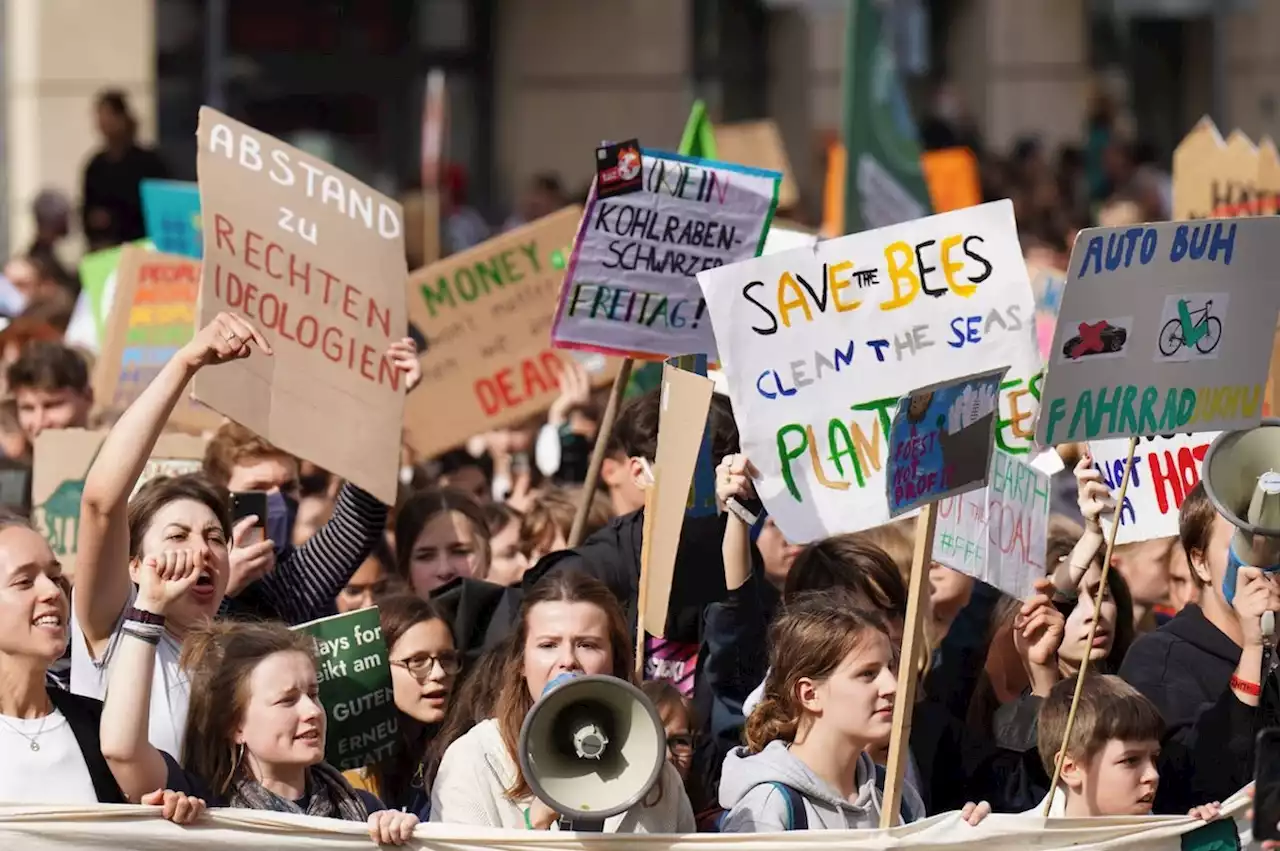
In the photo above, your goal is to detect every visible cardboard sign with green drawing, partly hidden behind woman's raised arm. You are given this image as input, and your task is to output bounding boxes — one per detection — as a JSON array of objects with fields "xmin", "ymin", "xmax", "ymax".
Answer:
[{"xmin": 31, "ymin": 429, "xmax": 205, "ymax": 575}]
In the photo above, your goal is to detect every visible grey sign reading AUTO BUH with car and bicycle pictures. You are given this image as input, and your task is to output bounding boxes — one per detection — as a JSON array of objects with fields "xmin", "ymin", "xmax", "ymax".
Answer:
[{"xmin": 1036, "ymin": 218, "xmax": 1280, "ymax": 445}]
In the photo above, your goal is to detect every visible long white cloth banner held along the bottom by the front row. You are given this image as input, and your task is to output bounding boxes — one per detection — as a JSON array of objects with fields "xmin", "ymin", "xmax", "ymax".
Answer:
[{"xmin": 0, "ymin": 793, "xmax": 1251, "ymax": 851}]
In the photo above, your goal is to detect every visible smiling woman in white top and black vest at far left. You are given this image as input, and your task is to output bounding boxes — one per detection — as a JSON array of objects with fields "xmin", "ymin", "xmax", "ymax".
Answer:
[{"xmin": 0, "ymin": 511, "xmax": 205, "ymax": 824}]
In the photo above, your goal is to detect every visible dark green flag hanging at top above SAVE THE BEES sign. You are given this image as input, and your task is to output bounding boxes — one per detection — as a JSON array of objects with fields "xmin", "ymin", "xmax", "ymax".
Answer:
[{"xmin": 844, "ymin": 0, "xmax": 933, "ymax": 233}]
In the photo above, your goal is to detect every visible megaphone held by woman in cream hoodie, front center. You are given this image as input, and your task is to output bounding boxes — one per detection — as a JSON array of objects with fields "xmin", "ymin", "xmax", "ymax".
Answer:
[{"xmin": 517, "ymin": 674, "xmax": 667, "ymax": 822}]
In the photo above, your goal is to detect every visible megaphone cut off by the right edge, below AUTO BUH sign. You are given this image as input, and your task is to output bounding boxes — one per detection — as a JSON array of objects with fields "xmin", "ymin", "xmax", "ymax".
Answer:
[{"xmin": 1201, "ymin": 420, "xmax": 1280, "ymax": 603}]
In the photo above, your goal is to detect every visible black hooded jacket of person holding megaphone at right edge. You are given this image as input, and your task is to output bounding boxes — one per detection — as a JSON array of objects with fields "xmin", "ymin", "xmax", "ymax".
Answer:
[{"xmin": 1120, "ymin": 605, "xmax": 1280, "ymax": 814}]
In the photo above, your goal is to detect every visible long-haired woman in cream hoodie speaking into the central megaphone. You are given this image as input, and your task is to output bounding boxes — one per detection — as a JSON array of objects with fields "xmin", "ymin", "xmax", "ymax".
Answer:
[{"xmin": 431, "ymin": 569, "xmax": 696, "ymax": 833}]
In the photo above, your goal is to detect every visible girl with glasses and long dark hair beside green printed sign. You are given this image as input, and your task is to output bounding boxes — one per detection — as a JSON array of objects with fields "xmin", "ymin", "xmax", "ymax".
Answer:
[{"xmin": 346, "ymin": 593, "xmax": 462, "ymax": 822}]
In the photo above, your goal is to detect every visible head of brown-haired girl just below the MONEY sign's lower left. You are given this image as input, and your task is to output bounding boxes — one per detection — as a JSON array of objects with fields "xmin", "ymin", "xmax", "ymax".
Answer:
[{"xmin": 396, "ymin": 489, "xmax": 489, "ymax": 599}]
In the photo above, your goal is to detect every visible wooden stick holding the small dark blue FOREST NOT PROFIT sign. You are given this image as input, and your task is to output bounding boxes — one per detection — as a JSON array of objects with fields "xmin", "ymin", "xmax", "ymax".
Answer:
[{"xmin": 881, "ymin": 503, "xmax": 938, "ymax": 829}]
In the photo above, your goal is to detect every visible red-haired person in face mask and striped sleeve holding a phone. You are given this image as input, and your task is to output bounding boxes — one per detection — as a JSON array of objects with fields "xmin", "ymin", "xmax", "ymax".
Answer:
[{"xmin": 204, "ymin": 338, "xmax": 422, "ymax": 624}]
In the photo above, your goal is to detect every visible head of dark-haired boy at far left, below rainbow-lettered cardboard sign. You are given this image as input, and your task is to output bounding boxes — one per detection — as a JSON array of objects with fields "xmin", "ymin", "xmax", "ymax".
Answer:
[{"xmin": 6, "ymin": 342, "xmax": 93, "ymax": 443}]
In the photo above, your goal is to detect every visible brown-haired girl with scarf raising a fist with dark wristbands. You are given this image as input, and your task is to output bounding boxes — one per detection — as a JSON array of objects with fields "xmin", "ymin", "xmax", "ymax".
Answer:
[{"xmin": 100, "ymin": 549, "xmax": 419, "ymax": 845}]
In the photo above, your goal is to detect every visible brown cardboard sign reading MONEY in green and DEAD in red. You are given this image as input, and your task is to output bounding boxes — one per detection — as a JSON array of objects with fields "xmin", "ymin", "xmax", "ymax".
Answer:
[{"xmin": 404, "ymin": 207, "xmax": 621, "ymax": 456}]
